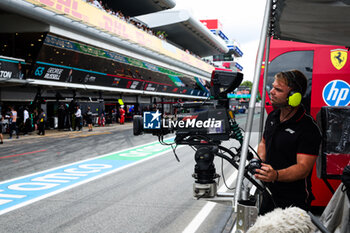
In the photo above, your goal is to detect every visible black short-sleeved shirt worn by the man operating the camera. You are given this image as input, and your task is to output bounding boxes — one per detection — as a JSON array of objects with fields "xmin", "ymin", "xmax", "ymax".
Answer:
[{"xmin": 264, "ymin": 106, "xmax": 321, "ymax": 201}]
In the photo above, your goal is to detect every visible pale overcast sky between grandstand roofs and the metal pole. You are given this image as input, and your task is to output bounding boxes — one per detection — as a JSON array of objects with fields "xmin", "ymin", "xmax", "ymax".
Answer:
[{"xmin": 174, "ymin": 0, "xmax": 266, "ymax": 81}]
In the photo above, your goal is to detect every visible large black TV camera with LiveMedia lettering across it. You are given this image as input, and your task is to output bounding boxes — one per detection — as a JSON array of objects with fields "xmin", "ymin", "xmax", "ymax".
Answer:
[{"xmin": 133, "ymin": 70, "xmax": 261, "ymax": 199}]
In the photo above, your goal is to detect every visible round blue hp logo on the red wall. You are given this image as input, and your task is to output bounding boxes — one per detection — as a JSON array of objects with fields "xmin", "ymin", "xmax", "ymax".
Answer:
[{"xmin": 322, "ymin": 80, "xmax": 350, "ymax": 106}]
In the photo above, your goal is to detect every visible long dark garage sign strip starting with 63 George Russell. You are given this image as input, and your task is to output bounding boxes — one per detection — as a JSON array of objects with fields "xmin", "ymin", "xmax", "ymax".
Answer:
[{"xmin": 32, "ymin": 62, "xmax": 208, "ymax": 97}]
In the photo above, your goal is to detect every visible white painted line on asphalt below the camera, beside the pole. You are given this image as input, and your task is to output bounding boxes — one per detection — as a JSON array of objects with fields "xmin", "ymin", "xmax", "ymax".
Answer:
[{"xmin": 182, "ymin": 145, "xmax": 258, "ymax": 233}]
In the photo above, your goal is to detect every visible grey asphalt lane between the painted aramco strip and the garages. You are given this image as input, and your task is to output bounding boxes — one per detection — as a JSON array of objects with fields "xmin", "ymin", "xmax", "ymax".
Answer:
[{"xmin": 0, "ymin": 123, "xmax": 137, "ymax": 181}]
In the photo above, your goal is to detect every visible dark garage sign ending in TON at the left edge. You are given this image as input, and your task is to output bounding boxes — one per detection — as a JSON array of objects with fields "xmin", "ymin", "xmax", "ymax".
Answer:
[{"xmin": 0, "ymin": 58, "xmax": 24, "ymax": 79}]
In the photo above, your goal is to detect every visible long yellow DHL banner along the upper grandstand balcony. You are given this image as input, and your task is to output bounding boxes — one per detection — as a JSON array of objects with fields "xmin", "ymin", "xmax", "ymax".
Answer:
[{"xmin": 24, "ymin": 0, "xmax": 214, "ymax": 73}]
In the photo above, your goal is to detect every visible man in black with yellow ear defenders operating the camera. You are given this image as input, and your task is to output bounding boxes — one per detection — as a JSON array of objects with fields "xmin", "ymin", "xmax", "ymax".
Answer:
[{"xmin": 255, "ymin": 70, "xmax": 321, "ymax": 214}]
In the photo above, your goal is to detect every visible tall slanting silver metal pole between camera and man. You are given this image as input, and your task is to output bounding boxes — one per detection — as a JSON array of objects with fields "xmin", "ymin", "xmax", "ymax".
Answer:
[{"xmin": 233, "ymin": 0, "xmax": 272, "ymax": 212}]
